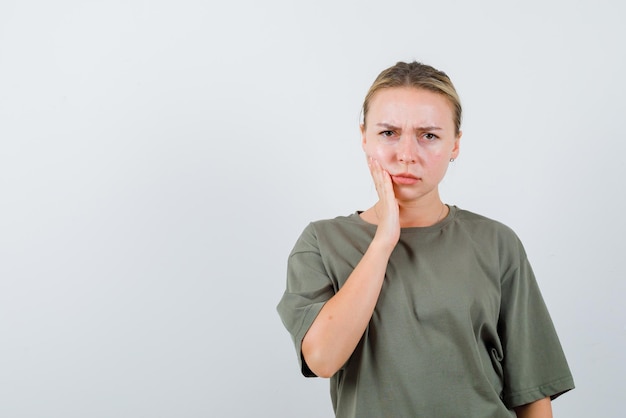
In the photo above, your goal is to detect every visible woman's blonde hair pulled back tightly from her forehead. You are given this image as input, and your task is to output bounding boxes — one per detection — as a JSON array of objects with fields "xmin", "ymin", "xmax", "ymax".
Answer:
[{"xmin": 363, "ymin": 61, "xmax": 462, "ymax": 135}]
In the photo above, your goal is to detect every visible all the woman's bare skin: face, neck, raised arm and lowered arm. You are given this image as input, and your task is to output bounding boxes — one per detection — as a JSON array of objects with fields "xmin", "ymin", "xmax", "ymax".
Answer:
[{"xmin": 302, "ymin": 87, "xmax": 551, "ymax": 417}]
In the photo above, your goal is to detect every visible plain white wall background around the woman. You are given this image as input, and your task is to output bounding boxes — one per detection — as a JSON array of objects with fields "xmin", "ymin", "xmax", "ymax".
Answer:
[{"xmin": 0, "ymin": 0, "xmax": 626, "ymax": 418}]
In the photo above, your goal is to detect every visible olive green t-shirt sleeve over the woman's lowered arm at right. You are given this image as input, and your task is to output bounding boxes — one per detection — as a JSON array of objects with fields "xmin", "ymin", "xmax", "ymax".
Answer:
[{"xmin": 498, "ymin": 229, "xmax": 574, "ymax": 408}]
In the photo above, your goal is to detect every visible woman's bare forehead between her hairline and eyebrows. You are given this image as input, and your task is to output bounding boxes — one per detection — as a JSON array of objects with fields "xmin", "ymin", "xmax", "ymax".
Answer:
[{"xmin": 367, "ymin": 87, "xmax": 454, "ymax": 127}]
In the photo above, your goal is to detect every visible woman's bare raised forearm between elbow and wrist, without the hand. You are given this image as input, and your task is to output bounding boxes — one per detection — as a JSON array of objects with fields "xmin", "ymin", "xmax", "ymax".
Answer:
[{"xmin": 302, "ymin": 240, "xmax": 393, "ymax": 377}]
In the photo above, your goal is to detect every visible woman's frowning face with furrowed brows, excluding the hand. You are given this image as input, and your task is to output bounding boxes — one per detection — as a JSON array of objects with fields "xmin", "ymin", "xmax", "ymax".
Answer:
[{"xmin": 361, "ymin": 87, "xmax": 461, "ymax": 202}]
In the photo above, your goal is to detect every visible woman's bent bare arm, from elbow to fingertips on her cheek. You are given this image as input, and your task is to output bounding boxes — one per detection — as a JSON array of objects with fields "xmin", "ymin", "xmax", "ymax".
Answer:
[{"xmin": 302, "ymin": 159, "xmax": 400, "ymax": 377}]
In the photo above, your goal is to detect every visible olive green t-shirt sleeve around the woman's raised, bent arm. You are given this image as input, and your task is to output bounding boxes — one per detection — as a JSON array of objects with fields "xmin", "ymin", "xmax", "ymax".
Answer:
[{"xmin": 277, "ymin": 224, "xmax": 335, "ymax": 377}]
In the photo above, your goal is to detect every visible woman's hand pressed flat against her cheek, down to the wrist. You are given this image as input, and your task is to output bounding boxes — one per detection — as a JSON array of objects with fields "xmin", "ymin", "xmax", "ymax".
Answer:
[{"xmin": 367, "ymin": 156, "xmax": 400, "ymax": 250}]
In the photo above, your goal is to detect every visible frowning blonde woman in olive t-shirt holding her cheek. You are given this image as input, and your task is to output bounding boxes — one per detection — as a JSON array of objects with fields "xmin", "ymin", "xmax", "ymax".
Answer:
[{"xmin": 278, "ymin": 62, "xmax": 574, "ymax": 418}]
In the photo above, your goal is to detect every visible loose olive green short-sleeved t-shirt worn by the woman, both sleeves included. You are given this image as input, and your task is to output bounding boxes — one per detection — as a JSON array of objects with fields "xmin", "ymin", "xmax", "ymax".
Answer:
[{"xmin": 278, "ymin": 206, "xmax": 574, "ymax": 418}]
